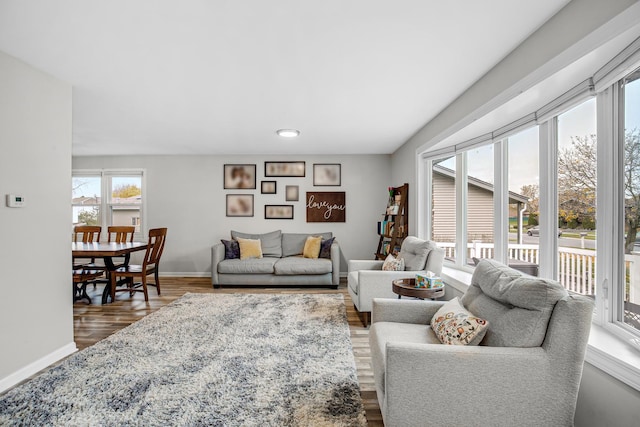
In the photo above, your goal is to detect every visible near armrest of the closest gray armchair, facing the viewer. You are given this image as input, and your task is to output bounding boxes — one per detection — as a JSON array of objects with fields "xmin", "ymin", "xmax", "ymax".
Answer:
[{"xmin": 385, "ymin": 342, "xmax": 552, "ymax": 426}]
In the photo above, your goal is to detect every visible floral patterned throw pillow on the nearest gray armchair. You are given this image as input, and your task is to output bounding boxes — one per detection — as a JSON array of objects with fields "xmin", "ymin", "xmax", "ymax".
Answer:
[{"xmin": 431, "ymin": 297, "xmax": 489, "ymax": 345}]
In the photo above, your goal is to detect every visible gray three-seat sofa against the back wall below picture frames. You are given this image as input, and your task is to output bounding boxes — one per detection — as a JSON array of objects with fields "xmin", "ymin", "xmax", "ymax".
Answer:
[{"xmin": 211, "ymin": 230, "xmax": 340, "ymax": 288}]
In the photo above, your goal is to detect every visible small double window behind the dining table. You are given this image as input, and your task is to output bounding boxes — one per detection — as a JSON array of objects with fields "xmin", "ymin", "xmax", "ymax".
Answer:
[{"xmin": 71, "ymin": 171, "xmax": 144, "ymax": 237}]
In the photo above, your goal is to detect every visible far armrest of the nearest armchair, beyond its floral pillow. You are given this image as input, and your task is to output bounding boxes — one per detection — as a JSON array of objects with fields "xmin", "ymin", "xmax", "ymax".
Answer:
[{"xmin": 371, "ymin": 298, "xmax": 444, "ymax": 325}]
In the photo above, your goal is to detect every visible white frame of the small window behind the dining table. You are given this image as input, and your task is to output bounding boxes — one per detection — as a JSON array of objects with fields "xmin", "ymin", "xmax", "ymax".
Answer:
[{"xmin": 71, "ymin": 169, "xmax": 148, "ymax": 241}]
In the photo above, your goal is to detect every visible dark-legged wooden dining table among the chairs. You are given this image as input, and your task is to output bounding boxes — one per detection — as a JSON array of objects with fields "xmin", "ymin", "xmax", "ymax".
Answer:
[{"xmin": 71, "ymin": 242, "xmax": 148, "ymax": 304}]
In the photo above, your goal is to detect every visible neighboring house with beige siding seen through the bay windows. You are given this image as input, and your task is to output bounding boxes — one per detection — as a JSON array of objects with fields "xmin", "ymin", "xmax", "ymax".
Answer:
[{"xmin": 431, "ymin": 165, "xmax": 528, "ymax": 243}]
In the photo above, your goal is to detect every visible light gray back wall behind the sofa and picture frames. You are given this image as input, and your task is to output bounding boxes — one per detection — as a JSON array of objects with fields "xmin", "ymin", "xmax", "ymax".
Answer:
[{"xmin": 73, "ymin": 155, "xmax": 392, "ymax": 276}]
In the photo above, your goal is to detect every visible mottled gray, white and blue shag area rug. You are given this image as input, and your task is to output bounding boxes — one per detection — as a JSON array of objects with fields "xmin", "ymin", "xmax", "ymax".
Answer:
[{"xmin": 0, "ymin": 294, "xmax": 366, "ymax": 426}]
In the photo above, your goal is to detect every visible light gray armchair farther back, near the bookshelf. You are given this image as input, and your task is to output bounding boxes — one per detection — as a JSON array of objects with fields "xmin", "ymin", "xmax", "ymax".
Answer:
[{"xmin": 347, "ymin": 236, "xmax": 444, "ymax": 326}]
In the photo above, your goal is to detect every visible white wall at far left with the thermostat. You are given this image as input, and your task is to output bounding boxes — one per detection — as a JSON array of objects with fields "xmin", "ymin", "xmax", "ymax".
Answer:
[{"xmin": 0, "ymin": 52, "xmax": 76, "ymax": 391}]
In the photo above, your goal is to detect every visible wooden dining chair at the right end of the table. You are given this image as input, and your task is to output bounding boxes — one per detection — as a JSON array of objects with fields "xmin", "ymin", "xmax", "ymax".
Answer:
[{"xmin": 111, "ymin": 228, "xmax": 167, "ymax": 301}]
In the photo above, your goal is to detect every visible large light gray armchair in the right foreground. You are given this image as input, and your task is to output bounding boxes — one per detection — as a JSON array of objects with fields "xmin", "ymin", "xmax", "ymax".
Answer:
[{"xmin": 369, "ymin": 260, "xmax": 593, "ymax": 427}]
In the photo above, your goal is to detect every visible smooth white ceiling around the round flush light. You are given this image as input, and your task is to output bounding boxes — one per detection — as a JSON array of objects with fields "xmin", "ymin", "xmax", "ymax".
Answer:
[{"xmin": 0, "ymin": 0, "xmax": 569, "ymax": 155}]
